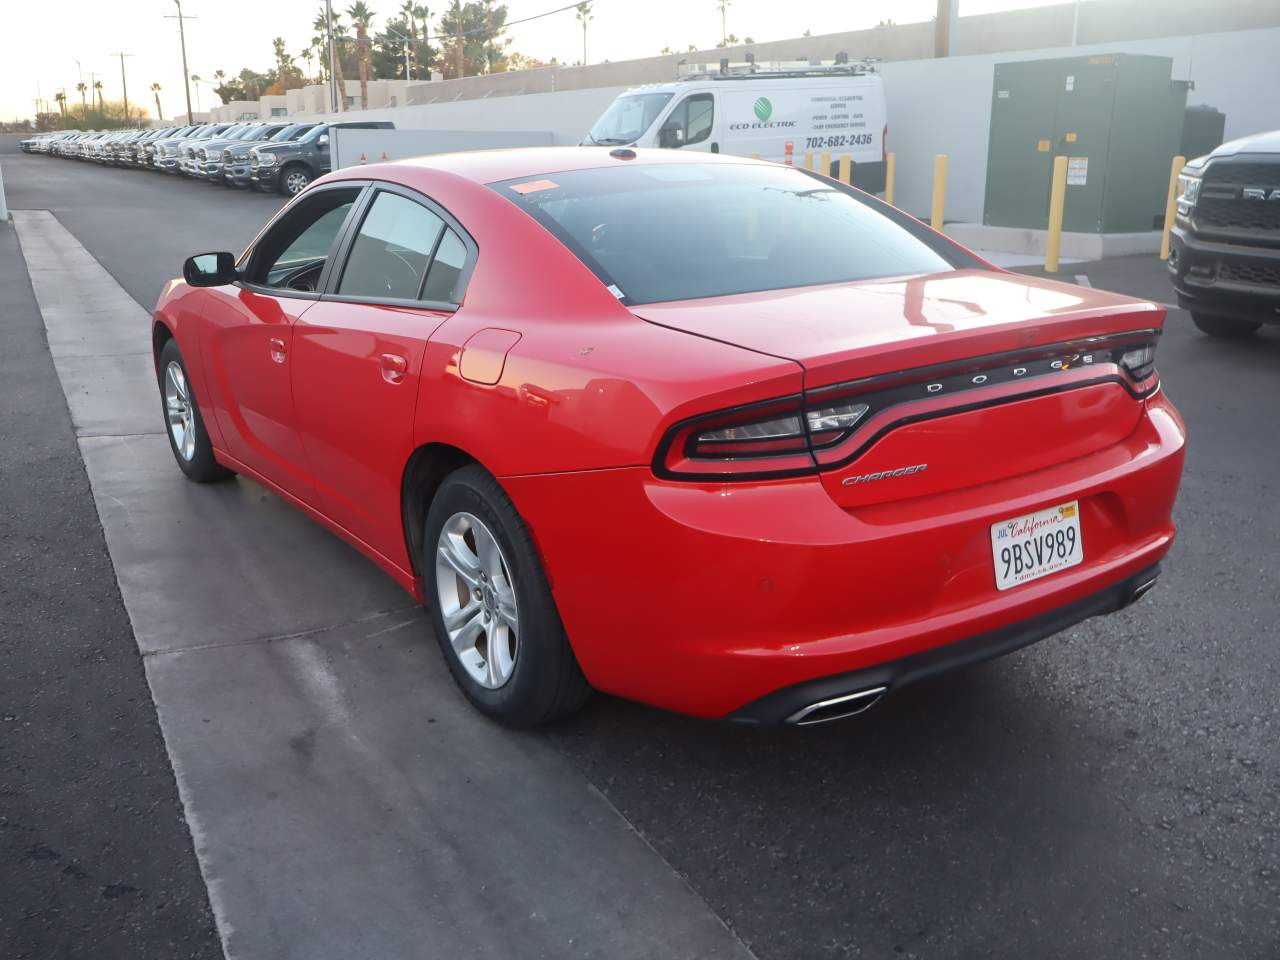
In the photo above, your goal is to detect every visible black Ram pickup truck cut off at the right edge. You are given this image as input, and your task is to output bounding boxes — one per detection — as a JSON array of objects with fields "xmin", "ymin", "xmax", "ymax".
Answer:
[{"xmin": 1169, "ymin": 131, "xmax": 1280, "ymax": 337}]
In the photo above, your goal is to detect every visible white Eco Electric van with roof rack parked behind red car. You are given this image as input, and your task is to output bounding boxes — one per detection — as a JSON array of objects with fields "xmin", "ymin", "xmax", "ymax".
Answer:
[{"xmin": 582, "ymin": 58, "xmax": 888, "ymax": 193}]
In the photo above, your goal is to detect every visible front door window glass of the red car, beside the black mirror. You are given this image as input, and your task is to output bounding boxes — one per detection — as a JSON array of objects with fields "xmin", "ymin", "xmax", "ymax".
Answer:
[{"xmin": 248, "ymin": 187, "xmax": 360, "ymax": 292}]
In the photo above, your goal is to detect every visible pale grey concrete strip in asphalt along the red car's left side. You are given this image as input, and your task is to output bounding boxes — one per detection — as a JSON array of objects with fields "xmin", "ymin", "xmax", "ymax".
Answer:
[{"xmin": 15, "ymin": 211, "xmax": 751, "ymax": 960}]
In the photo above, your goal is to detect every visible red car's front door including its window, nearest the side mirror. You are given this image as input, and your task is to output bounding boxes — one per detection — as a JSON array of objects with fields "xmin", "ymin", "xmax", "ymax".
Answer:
[{"xmin": 202, "ymin": 187, "xmax": 360, "ymax": 500}]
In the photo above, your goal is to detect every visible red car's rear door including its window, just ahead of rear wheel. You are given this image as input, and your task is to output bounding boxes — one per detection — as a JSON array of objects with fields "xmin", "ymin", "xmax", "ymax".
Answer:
[{"xmin": 292, "ymin": 183, "xmax": 475, "ymax": 568}]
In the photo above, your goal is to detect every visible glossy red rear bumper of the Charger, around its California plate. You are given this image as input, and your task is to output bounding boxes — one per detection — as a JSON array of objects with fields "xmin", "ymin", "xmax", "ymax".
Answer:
[{"xmin": 502, "ymin": 394, "xmax": 1185, "ymax": 721}]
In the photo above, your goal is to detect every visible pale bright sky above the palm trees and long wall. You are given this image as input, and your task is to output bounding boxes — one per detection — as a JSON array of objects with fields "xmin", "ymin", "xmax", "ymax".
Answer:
[{"xmin": 0, "ymin": 0, "xmax": 1062, "ymax": 120}]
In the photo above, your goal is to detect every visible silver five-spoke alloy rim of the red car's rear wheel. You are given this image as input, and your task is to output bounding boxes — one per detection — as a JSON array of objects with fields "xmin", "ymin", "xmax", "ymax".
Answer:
[{"xmin": 435, "ymin": 512, "xmax": 520, "ymax": 690}]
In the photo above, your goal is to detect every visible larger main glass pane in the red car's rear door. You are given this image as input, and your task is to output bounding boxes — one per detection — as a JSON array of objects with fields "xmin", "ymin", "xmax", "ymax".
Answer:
[{"xmin": 338, "ymin": 191, "xmax": 444, "ymax": 300}]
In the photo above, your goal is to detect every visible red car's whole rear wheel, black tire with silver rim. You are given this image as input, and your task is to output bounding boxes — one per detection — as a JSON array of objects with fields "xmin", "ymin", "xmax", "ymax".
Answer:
[{"xmin": 420, "ymin": 465, "xmax": 591, "ymax": 727}]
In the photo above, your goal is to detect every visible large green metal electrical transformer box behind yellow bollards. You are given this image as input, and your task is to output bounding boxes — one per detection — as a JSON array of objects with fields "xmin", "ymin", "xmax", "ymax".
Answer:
[{"xmin": 983, "ymin": 54, "xmax": 1189, "ymax": 233}]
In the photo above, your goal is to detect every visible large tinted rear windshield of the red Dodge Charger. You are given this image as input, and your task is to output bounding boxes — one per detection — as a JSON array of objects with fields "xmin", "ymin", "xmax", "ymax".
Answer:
[{"xmin": 492, "ymin": 163, "xmax": 962, "ymax": 303}]
